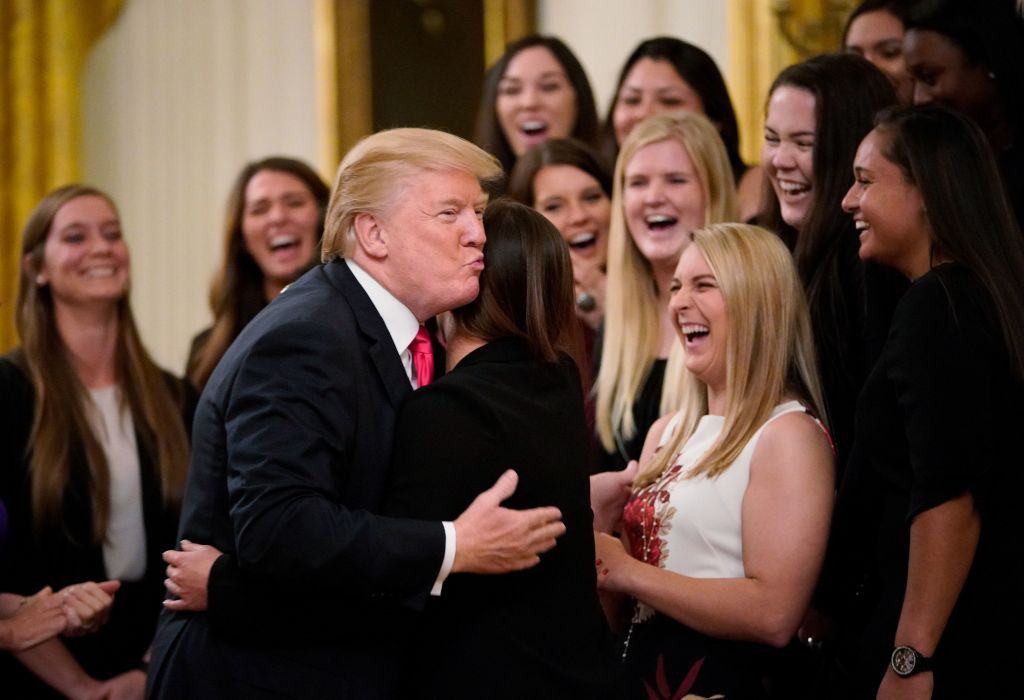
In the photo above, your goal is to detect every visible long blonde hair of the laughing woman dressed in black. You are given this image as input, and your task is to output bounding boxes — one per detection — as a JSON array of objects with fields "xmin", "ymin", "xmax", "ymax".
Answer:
[{"xmin": 595, "ymin": 113, "xmax": 736, "ymax": 451}]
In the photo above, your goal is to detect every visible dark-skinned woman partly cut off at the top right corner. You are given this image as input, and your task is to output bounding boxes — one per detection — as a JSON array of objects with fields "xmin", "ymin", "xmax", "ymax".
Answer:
[{"xmin": 903, "ymin": 0, "xmax": 1024, "ymax": 229}]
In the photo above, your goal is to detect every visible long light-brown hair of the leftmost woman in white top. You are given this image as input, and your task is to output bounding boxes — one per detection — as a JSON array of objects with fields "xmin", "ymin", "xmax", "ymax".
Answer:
[{"xmin": 16, "ymin": 184, "xmax": 188, "ymax": 543}]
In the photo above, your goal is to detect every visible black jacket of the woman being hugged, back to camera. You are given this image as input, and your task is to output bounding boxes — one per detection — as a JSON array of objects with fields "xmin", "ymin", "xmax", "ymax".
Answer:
[{"xmin": 384, "ymin": 339, "xmax": 618, "ymax": 699}]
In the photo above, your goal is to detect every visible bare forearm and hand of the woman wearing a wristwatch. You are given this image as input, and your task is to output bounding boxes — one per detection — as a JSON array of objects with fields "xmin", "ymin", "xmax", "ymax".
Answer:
[{"xmin": 879, "ymin": 491, "xmax": 981, "ymax": 698}]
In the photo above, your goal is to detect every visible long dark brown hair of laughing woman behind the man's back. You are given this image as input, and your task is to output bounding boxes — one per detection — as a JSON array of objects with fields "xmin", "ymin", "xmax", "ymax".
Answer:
[{"xmin": 185, "ymin": 156, "xmax": 331, "ymax": 389}]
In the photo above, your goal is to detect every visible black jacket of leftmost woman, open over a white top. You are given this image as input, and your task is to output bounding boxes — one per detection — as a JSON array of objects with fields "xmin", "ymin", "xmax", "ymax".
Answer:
[{"xmin": 0, "ymin": 351, "xmax": 195, "ymax": 699}]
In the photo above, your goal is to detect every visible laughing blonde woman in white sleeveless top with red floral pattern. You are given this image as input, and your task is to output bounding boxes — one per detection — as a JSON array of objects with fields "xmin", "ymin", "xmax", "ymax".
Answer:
[{"xmin": 597, "ymin": 224, "xmax": 834, "ymax": 698}]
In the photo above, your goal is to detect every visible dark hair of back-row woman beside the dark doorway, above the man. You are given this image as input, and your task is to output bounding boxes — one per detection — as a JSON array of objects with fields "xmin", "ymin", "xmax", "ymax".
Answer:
[{"xmin": 473, "ymin": 34, "xmax": 598, "ymax": 173}]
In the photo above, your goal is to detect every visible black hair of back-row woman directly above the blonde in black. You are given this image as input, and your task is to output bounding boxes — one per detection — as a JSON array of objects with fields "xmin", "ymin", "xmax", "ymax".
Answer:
[{"xmin": 601, "ymin": 37, "xmax": 746, "ymax": 181}]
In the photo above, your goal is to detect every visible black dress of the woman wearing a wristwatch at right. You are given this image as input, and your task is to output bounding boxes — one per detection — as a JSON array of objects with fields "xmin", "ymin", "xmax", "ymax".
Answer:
[{"xmin": 827, "ymin": 264, "xmax": 1024, "ymax": 698}]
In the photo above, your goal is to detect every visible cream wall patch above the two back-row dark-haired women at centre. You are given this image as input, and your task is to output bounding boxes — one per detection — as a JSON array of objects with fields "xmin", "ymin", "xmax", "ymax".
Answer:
[{"xmin": 538, "ymin": 0, "xmax": 729, "ymax": 117}]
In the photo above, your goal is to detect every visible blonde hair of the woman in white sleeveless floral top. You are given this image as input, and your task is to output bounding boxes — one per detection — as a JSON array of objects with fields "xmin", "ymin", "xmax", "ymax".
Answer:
[{"xmin": 636, "ymin": 224, "xmax": 824, "ymax": 486}]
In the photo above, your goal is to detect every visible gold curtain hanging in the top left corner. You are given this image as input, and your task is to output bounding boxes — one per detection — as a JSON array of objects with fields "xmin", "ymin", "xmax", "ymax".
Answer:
[{"xmin": 0, "ymin": 0, "xmax": 123, "ymax": 352}]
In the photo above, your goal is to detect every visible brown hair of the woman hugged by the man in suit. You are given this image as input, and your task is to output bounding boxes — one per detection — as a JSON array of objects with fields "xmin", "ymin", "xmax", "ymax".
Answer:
[{"xmin": 453, "ymin": 199, "xmax": 581, "ymax": 366}]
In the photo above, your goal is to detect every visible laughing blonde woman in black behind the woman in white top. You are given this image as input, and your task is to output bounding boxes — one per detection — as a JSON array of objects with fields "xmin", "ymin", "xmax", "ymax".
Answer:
[{"xmin": 596, "ymin": 113, "xmax": 736, "ymax": 471}]
